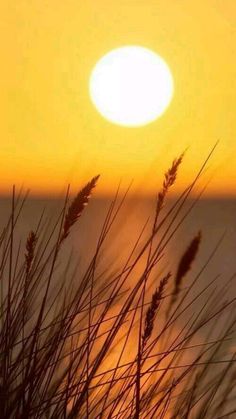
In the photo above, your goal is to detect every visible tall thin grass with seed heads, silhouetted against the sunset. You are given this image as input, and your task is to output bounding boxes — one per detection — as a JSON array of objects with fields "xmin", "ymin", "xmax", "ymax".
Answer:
[{"xmin": 0, "ymin": 149, "xmax": 236, "ymax": 419}]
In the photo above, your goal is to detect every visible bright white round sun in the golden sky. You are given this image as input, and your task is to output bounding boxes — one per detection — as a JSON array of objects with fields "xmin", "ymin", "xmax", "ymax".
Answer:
[{"xmin": 89, "ymin": 46, "xmax": 173, "ymax": 127}]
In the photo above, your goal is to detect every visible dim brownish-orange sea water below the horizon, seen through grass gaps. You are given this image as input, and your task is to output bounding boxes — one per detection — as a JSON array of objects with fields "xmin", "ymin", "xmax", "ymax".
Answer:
[{"xmin": 0, "ymin": 197, "xmax": 236, "ymax": 414}]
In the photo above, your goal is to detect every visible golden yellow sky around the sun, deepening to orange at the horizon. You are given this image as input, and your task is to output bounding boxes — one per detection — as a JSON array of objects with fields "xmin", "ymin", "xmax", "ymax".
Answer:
[{"xmin": 0, "ymin": 0, "xmax": 236, "ymax": 195}]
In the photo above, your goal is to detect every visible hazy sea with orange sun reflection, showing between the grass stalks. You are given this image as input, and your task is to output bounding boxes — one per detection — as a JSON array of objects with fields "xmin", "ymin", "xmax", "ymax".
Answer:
[{"xmin": 0, "ymin": 197, "xmax": 236, "ymax": 414}]
